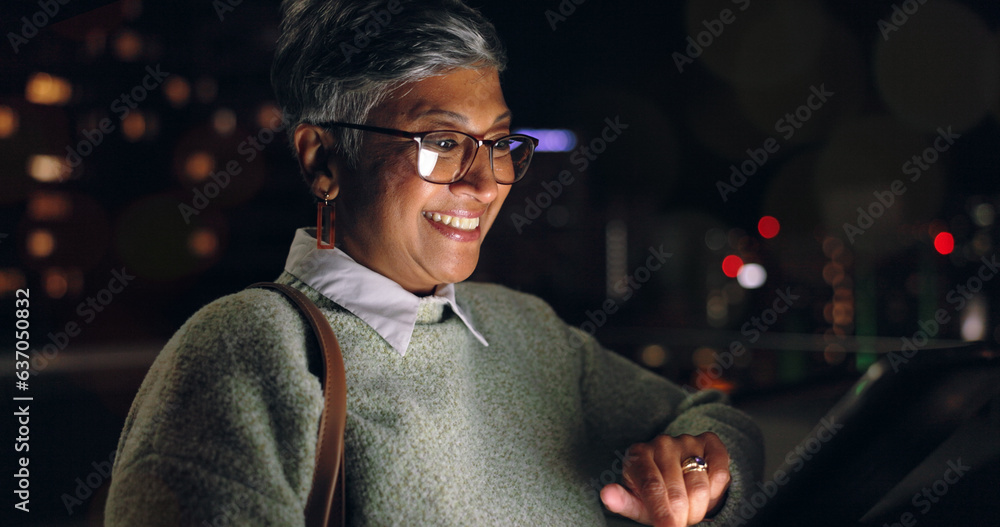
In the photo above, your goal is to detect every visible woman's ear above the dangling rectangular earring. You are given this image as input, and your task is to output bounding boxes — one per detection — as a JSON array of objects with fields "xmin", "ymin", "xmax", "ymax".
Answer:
[{"xmin": 293, "ymin": 124, "xmax": 346, "ymax": 199}]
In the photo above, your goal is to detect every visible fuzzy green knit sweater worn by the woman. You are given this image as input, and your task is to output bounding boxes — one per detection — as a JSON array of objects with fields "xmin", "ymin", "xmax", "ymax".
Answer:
[{"xmin": 106, "ymin": 273, "xmax": 763, "ymax": 527}]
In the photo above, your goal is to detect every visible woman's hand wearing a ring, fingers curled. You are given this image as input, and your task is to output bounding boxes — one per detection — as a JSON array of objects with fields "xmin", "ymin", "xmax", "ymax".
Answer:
[{"xmin": 601, "ymin": 432, "xmax": 729, "ymax": 527}]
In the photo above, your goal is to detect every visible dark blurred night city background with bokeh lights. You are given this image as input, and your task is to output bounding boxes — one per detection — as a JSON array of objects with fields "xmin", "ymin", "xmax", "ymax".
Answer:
[{"xmin": 0, "ymin": 0, "xmax": 1000, "ymax": 525}]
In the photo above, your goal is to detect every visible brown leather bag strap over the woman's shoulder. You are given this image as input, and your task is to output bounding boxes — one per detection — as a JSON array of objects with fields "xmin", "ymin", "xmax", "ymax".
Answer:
[{"xmin": 248, "ymin": 282, "xmax": 347, "ymax": 527}]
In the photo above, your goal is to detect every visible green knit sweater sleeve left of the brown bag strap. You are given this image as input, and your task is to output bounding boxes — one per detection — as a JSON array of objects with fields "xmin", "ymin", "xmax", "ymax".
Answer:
[{"xmin": 105, "ymin": 290, "xmax": 323, "ymax": 527}]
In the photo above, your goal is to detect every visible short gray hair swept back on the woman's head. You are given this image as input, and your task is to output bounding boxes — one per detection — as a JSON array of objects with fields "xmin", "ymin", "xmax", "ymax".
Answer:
[{"xmin": 271, "ymin": 0, "xmax": 507, "ymax": 167}]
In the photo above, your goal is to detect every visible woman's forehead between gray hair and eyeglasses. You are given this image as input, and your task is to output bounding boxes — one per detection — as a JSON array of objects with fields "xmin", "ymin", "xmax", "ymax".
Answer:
[{"xmin": 373, "ymin": 68, "xmax": 510, "ymax": 131}]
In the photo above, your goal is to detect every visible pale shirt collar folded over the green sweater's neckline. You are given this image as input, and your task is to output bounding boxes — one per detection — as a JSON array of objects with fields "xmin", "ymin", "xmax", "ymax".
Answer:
[{"xmin": 285, "ymin": 228, "xmax": 489, "ymax": 355}]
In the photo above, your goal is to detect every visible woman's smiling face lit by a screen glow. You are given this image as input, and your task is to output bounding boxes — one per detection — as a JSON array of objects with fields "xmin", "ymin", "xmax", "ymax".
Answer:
[{"xmin": 337, "ymin": 68, "xmax": 510, "ymax": 294}]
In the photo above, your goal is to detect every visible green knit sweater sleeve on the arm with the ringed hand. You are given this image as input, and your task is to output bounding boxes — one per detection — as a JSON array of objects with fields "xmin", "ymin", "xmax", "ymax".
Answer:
[{"xmin": 568, "ymin": 328, "xmax": 764, "ymax": 525}]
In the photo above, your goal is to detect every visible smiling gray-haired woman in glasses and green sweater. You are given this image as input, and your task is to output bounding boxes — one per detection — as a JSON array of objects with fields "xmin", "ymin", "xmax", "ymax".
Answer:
[{"xmin": 107, "ymin": 0, "xmax": 762, "ymax": 526}]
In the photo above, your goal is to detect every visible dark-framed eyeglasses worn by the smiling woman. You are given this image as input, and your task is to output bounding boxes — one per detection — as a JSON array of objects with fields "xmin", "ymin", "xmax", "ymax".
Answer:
[{"xmin": 316, "ymin": 122, "xmax": 538, "ymax": 185}]
